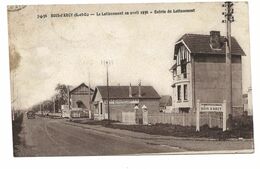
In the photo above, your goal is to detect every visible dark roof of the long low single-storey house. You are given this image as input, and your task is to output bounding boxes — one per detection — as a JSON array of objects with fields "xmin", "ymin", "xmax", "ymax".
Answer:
[{"xmin": 93, "ymin": 86, "xmax": 161, "ymax": 100}]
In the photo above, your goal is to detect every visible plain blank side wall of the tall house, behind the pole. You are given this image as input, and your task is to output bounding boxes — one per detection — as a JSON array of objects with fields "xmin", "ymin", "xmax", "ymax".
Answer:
[{"xmin": 193, "ymin": 55, "xmax": 243, "ymax": 115}]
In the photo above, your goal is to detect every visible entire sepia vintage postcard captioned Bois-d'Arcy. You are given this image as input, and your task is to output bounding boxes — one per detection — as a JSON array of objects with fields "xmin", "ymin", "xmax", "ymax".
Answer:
[{"xmin": 7, "ymin": 2, "xmax": 254, "ymax": 157}]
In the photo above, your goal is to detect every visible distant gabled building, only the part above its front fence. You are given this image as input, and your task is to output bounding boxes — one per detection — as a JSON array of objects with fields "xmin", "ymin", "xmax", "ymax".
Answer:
[{"xmin": 69, "ymin": 83, "xmax": 94, "ymax": 110}]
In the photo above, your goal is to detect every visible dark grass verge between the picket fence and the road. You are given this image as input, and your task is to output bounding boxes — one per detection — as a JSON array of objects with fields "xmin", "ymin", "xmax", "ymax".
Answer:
[{"xmin": 73, "ymin": 120, "xmax": 253, "ymax": 140}]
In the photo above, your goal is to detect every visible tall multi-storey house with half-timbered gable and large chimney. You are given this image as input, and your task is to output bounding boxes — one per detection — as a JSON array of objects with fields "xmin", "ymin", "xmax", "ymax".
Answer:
[{"xmin": 170, "ymin": 31, "xmax": 245, "ymax": 115}]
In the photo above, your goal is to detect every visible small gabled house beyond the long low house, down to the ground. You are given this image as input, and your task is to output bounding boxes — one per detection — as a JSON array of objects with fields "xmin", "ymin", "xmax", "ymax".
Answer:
[{"xmin": 69, "ymin": 83, "xmax": 94, "ymax": 117}]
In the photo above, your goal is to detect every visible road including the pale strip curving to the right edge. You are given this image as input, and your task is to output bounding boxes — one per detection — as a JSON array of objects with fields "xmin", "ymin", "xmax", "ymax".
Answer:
[{"xmin": 17, "ymin": 117, "xmax": 253, "ymax": 156}]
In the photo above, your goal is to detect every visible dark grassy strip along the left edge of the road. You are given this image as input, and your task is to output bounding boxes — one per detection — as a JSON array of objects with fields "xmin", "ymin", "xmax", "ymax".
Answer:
[{"xmin": 12, "ymin": 114, "xmax": 23, "ymax": 156}]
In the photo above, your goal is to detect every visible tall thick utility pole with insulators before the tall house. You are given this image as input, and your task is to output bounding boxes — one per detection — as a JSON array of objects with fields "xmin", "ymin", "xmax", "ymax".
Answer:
[{"xmin": 222, "ymin": 1, "xmax": 235, "ymax": 120}]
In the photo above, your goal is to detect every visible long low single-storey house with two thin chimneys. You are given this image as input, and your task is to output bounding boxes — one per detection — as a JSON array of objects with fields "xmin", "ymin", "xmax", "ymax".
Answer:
[{"xmin": 92, "ymin": 84, "xmax": 160, "ymax": 123}]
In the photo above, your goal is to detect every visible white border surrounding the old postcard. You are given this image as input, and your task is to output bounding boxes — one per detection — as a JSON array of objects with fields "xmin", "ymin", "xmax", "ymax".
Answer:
[{"xmin": 0, "ymin": 0, "xmax": 260, "ymax": 169}]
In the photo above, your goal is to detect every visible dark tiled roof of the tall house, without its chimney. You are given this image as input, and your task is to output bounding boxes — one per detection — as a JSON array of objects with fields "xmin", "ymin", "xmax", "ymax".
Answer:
[{"xmin": 174, "ymin": 34, "xmax": 246, "ymax": 59}]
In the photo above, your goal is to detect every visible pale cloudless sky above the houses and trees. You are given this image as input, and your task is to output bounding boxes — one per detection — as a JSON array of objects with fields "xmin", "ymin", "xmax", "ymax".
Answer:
[{"xmin": 8, "ymin": 2, "xmax": 251, "ymax": 108}]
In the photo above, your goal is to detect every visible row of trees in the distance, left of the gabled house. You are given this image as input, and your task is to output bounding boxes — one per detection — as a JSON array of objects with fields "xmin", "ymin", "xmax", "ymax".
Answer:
[{"xmin": 31, "ymin": 83, "xmax": 69, "ymax": 113}]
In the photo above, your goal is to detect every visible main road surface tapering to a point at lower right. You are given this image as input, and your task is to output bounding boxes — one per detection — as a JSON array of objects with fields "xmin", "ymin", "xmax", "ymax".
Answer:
[{"xmin": 18, "ymin": 117, "xmax": 183, "ymax": 156}]
